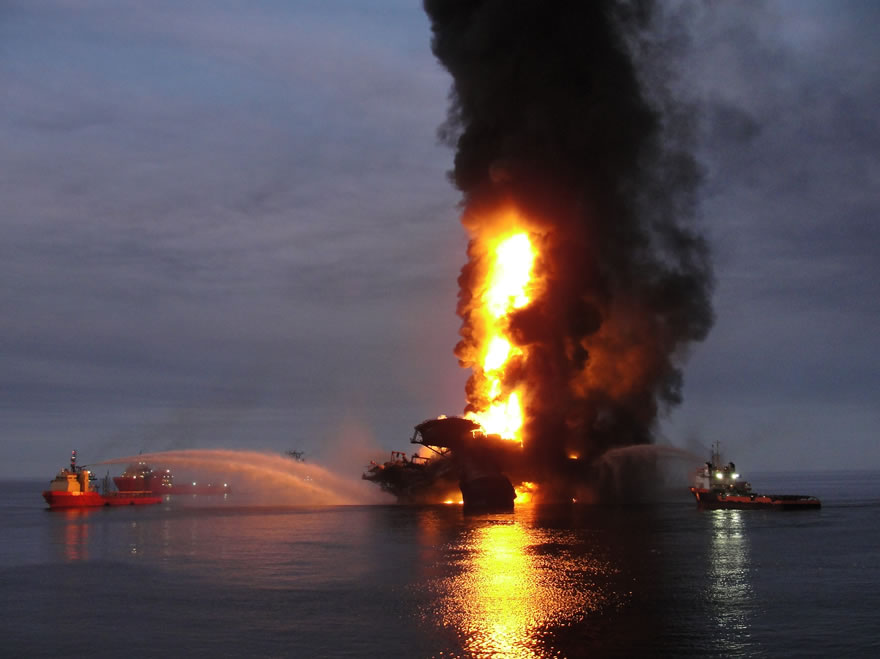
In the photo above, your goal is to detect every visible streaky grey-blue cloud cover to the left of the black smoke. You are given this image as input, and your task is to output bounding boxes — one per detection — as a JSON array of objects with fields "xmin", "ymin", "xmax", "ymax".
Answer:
[{"xmin": 0, "ymin": 2, "xmax": 463, "ymax": 474}]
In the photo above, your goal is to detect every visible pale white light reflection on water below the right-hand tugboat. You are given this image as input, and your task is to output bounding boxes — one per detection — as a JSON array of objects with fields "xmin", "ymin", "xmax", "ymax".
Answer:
[{"xmin": 708, "ymin": 510, "xmax": 753, "ymax": 651}]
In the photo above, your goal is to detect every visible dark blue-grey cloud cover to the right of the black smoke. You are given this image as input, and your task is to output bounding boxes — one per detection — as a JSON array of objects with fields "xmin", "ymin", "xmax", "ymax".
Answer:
[{"xmin": 670, "ymin": 3, "xmax": 880, "ymax": 466}]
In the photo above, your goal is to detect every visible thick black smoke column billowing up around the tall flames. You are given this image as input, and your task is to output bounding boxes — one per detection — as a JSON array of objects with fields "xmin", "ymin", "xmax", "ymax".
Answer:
[{"xmin": 425, "ymin": 0, "xmax": 713, "ymax": 480}]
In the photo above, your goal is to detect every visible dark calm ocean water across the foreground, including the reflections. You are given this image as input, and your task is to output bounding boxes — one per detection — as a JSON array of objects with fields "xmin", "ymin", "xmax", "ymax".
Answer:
[{"xmin": 0, "ymin": 472, "xmax": 880, "ymax": 658}]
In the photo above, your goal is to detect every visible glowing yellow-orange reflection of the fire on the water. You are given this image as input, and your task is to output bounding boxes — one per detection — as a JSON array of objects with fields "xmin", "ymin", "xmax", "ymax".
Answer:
[{"xmin": 434, "ymin": 517, "xmax": 611, "ymax": 657}]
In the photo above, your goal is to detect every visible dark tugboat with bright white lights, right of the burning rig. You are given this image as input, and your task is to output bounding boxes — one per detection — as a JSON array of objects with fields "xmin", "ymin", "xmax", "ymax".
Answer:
[{"xmin": 690, "ymin": 442, "xmax": 822, "ymax": 510}]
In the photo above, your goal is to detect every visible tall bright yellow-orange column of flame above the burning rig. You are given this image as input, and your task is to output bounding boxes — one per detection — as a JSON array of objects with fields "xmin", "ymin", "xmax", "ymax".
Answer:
[{"xmin": 466, "ymin": 220, "xmax": 538, "ymax": 442}]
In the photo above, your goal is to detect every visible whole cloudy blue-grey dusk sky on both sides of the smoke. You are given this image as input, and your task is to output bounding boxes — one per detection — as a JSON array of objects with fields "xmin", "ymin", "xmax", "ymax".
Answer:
[{"xmin": 0, "ymin": 0, "xmax": 880, "ymax": 479}]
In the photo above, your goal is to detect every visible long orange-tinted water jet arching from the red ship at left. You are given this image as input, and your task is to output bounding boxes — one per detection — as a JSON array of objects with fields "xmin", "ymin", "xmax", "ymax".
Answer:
[{"xmin": 98, "ymin": 449, "xmax": 387, "ymax": 505}]
